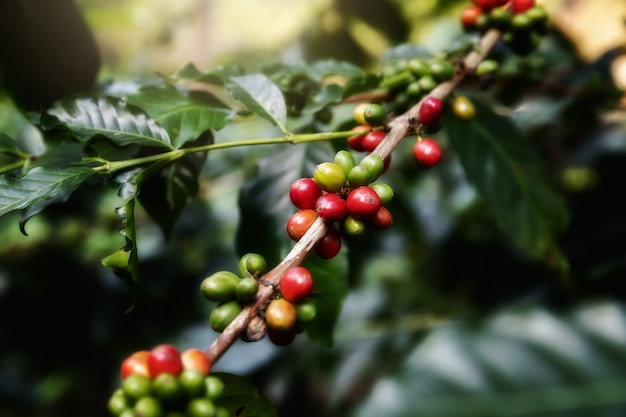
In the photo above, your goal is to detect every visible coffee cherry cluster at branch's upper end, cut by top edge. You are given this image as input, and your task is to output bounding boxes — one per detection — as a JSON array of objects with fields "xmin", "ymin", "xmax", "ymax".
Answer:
[{"xmin": 461, "ymin": 0, "xmax": 549, "ymax": 55}]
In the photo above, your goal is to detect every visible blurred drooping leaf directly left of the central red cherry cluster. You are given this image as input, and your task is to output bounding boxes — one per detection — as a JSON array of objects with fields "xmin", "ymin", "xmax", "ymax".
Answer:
[{"xmin": 237, "ymin": 143, "xmax": 334, "ymax": 264}]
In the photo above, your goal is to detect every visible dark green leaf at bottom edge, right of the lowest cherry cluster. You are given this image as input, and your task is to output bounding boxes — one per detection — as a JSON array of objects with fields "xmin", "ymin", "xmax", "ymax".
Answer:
[{"xmin": 211, "ymin": 372, "xmax": 278, "ymax": 417}]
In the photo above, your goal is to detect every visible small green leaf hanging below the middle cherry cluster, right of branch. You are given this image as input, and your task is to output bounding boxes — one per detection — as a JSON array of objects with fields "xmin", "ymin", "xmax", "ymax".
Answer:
[{"xmin": 304, "ymin": 250, "xmax": 349, "ymax": 347}]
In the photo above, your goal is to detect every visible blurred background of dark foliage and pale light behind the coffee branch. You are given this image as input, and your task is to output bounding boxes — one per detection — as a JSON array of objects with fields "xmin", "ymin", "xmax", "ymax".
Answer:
[{"xmin": 0, "ymin": 0, "xmax": 626, "ymax": 417}]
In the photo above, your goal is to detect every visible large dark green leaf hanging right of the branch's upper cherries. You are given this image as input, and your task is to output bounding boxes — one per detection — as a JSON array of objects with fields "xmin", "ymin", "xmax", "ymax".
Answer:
[{"xmin": 445, "ymin": 100, "xmax": 570, "ymax": 257}]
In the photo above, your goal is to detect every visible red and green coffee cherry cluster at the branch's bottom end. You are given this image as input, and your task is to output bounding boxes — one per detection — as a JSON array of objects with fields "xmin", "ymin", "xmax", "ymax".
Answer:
[{"xmin": 108, "ymin": 344, "xmax": 229, "ymax": 417}]
